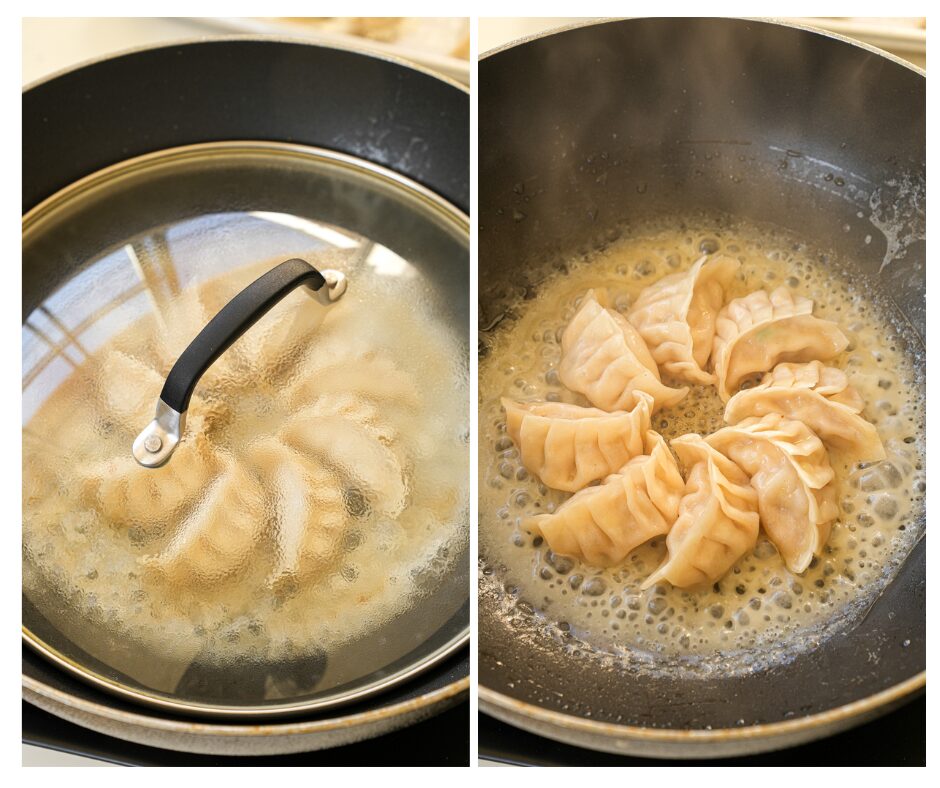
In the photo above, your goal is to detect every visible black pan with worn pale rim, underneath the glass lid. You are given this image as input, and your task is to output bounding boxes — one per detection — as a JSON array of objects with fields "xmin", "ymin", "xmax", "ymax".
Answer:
[{"xmin": 22, "ymin": 39, "xmax": 469, "ymax": 754}]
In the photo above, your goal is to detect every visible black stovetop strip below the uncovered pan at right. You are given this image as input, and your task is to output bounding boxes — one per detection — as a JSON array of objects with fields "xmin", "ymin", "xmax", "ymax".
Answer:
[{"xmin": 479, "ymin": 695, "xmax": 927, "ymax": 766}]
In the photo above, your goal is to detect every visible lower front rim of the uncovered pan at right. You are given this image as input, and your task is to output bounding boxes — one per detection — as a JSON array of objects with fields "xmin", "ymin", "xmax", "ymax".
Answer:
[{"xmin": 478, "ymin": 670, "xmax": 927, "ymax": 744}]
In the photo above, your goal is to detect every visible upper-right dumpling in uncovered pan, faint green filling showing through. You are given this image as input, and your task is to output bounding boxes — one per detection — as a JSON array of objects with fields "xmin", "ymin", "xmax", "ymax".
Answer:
[{"xmin": 712, "ymin": 287, "xmax": 849, "ymax": 402}]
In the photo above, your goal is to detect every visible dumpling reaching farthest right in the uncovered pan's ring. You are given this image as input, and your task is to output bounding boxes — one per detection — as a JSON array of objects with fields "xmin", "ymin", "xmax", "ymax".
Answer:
[{"xmin": 725, "ymin": 361, "xmax": 885, "ymax": 462}]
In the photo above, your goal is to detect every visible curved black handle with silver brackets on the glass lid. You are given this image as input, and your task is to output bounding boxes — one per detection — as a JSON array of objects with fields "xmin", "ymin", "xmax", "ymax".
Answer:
[{"xmin": 133, "ymin": 258, "xmax": 346, "ymax": 468}]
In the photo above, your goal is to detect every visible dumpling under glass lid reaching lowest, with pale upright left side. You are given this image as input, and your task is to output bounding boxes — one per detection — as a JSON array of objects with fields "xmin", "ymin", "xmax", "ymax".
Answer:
[{"xmin": 246, "ymin": 438, "xmax": 348, "ymax": 586}]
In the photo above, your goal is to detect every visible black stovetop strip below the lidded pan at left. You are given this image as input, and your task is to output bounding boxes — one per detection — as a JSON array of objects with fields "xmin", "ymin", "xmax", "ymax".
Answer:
[{"xmin": 23, "ymin": 701, "xmax": 470, "ymax": 766}]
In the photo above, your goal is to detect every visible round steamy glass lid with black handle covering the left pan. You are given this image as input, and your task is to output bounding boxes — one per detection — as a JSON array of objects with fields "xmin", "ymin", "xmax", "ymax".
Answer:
[{"xmin": 22, "ymin": 142, "xmax": 470, "ymax": 716}]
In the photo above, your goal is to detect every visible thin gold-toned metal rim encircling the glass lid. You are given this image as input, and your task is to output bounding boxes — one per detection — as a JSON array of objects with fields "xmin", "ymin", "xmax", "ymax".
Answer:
[{"xmin": 21, "ymin": 140, "xmax": 471, "ymax": 719}]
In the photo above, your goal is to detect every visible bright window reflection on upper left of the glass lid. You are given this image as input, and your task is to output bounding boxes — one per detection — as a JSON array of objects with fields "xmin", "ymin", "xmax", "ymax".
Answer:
[{"xmin": 23, "ymin": 211, "xmax": 419, "ymax": 424}]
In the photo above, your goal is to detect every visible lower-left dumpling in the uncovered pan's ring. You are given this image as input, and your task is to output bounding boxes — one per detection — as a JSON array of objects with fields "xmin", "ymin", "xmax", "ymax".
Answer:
[{"xmin": 528, "ymin": 432, "xmax": 685, "ymax": 566}]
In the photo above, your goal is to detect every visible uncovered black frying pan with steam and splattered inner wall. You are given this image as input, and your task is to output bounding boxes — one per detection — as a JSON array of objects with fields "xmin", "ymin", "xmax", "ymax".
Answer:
[{"xmin": 479, "ymin": 19, "xmax": 926, "ymax": 757}]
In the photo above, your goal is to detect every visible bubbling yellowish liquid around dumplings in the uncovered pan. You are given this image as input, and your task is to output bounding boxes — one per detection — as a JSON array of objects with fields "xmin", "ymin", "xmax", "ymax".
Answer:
[{"xmin": 479, "ymin": 214, "xmax": 926, "ymax": 675}]
